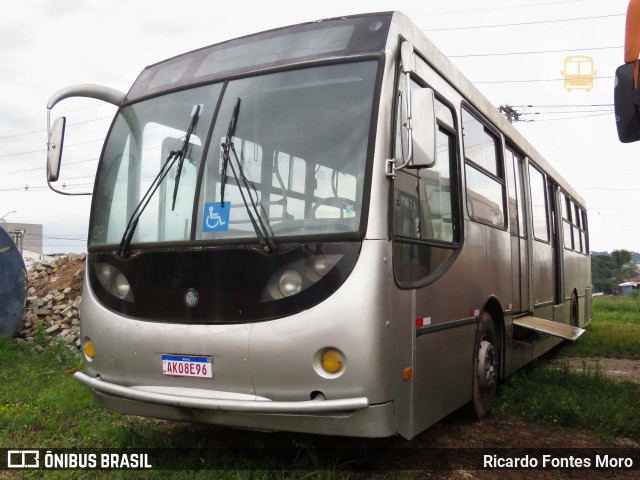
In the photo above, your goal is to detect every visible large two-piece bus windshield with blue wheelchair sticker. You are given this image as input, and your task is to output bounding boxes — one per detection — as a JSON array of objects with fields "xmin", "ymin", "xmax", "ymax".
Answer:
[{"xmin": 90, "ymin": 61, "xmax": 378, "ymax": 246}]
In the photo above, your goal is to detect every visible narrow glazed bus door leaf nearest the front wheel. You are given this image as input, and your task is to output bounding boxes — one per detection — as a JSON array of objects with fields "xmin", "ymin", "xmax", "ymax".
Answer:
[{"xmin": 505, "ymin": 146, "xmax": 530, "ymax": 314}]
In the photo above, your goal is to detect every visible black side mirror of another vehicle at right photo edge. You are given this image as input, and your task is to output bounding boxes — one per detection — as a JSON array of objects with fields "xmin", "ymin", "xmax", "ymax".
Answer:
[{"xmin": 613, "ymin": 61, "xmax": 640, "ymax": 143}]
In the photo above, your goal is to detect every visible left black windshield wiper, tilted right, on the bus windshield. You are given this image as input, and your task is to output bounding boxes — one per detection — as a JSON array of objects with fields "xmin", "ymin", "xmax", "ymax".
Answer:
[{"xmin": 118, "ymin": 105, "xmax": 200, "ymax": 257}]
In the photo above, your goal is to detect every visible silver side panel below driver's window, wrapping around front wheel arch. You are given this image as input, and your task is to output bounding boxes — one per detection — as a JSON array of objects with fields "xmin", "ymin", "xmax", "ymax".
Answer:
[{"xmin": 413, "ymin": 221, "xmax": 511, "ymax": 434}]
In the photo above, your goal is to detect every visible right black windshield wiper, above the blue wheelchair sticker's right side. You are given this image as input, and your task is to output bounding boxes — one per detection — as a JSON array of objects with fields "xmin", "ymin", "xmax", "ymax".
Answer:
[{"xmin": 220, "ymin": 98, "xmax": 278, "ymax": 253}]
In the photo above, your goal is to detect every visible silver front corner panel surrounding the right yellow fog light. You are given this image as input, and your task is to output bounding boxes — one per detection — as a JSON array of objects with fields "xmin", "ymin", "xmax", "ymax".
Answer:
[{"xmin": 249, "ymin": 240, "xmax": 402, "ymax": 435}]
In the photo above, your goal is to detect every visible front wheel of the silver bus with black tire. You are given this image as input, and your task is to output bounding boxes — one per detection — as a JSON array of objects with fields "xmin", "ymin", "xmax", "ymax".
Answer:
[{"xmin": 471, "ymin": 310, "xmax": 500, "ymax": 419}]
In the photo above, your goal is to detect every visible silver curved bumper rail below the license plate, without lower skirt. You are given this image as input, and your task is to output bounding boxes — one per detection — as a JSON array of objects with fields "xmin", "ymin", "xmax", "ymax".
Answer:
[{"xmin": 74, "ymin": 372, "xmax": 369, "ymax": 414}]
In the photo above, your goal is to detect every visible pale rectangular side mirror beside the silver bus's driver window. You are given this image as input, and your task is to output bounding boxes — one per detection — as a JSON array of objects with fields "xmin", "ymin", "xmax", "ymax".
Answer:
[{"xmin": 407, "ymin": 88, "xmax": 436, "ymax": 168}]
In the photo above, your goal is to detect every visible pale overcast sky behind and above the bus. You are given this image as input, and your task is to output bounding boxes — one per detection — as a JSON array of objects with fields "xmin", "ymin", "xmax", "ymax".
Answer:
[{"xmin": 0, "ymin": 0, "xmax": 640, "ymax": 252}]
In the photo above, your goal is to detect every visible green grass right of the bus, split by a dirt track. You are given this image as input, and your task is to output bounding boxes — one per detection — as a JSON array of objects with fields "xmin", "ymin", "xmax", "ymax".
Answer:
[{"xmin": 496, "ymin": 296, "xmax": 640, "ymax": 440}]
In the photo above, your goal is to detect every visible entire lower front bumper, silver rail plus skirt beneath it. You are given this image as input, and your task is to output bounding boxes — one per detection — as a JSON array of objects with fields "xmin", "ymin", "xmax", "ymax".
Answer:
[{"xmin": 74, "ymin": 372, "xmax": 397, "ymax": 437}]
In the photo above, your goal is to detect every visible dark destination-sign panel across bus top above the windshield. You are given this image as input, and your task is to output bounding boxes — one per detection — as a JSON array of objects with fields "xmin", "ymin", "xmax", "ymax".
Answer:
[{"xmin": 125, "ymin": 13, "xmax": 392, "ymax": 102}]
